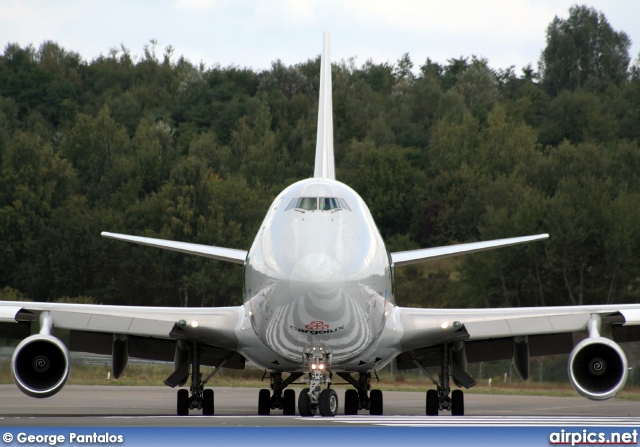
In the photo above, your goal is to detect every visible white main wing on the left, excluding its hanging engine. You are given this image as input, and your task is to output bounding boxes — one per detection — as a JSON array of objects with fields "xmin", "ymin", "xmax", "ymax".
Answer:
[{"xmin": 0, "ymin": 301, "xmax": 244, "ymax": 368}]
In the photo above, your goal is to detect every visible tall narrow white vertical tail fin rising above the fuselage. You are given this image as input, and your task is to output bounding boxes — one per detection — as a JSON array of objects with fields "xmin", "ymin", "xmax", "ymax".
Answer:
[{"xmin": 313, "ymin": 31, "xmax": 336, "ymax": 180}]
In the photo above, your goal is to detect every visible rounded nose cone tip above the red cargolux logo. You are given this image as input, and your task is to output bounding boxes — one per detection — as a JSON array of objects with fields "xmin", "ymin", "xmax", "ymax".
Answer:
[{"xmin": 289, "ymin": 253, "xmax": 344, "ymax": 310}]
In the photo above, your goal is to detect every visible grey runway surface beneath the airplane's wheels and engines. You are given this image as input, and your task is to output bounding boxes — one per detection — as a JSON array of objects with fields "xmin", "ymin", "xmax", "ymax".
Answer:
[{"xmin": 0, "ymin": 385, "xmax": 640, "ymax": 427}]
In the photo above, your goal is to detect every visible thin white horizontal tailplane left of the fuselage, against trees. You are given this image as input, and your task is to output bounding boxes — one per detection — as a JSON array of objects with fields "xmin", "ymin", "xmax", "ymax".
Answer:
[{"xmin": 101, "ymin": 231, "xmax": 247, "ymax": 264}]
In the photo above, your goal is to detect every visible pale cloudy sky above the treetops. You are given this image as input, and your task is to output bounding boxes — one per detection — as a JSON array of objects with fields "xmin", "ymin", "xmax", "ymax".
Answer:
[{"xmin": 0, "ymin": 0, "xmax": 640, "ymax": 73}]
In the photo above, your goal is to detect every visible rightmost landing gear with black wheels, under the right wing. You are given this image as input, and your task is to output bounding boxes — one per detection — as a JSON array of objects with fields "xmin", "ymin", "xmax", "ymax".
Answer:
[{"xmin": 414, "ymin": 343, "xmax": 476, "ymax": 416}]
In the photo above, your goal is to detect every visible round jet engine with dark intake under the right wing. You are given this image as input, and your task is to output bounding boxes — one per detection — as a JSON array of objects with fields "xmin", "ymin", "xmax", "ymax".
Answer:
[{"xmin": 567, "ymin": 337, "xmax": 627, "ymax": 400}]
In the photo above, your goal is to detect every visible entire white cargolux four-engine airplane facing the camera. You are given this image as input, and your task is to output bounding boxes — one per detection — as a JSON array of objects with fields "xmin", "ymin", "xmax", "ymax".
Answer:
[{"xmin": 0, "ymin": 34, "xmax": 640, "ymax": 416}]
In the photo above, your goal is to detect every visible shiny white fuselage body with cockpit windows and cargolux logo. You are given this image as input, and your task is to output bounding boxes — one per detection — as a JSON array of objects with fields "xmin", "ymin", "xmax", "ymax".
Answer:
[{"xmin": 244, "ymin": 178, "xmax": 395, "ymax": 370}]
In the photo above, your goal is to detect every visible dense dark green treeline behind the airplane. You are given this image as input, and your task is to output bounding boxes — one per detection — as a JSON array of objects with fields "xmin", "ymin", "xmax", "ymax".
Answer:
[{"xmin": 0, "ymin": 6, "xmax": 640, "ymax": 307}]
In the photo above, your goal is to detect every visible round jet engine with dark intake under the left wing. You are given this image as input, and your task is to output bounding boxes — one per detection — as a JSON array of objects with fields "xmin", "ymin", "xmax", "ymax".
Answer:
[{"xmin": 11, "ymin": 334, "xmax": 71, "ymax": 397}]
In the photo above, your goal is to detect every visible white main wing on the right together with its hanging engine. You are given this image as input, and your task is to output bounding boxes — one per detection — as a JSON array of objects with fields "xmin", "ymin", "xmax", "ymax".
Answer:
[{"xmin": 396, "ymin": 304, "xmax": 640, "ymax": 400}]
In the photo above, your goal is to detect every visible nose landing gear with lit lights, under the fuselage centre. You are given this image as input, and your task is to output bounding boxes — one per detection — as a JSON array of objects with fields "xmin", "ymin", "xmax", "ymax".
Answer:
[{"xmin": 298, "ymin": 348, "xmax": 338, "ymax": 416}]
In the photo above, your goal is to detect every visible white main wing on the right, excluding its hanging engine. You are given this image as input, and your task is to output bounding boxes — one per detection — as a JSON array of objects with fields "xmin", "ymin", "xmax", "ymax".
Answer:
[{"xmin": 397, "ymin": 304, "xmax": 640, "ymax": 367}]
